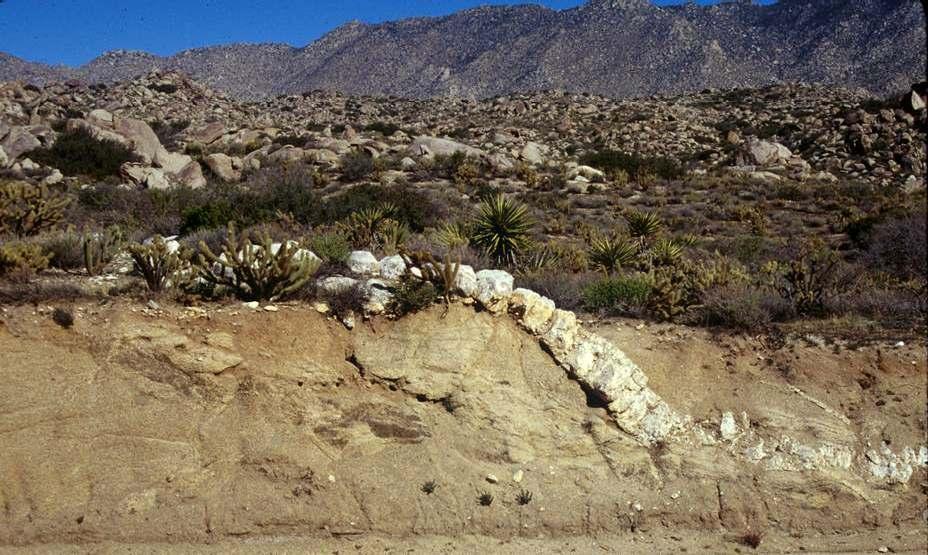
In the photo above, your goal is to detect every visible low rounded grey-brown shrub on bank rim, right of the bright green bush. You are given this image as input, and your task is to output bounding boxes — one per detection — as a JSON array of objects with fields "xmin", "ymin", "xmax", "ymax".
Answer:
[{"xmin": 700, "ymin": 284, "xmax": 792, "ymax": 331}]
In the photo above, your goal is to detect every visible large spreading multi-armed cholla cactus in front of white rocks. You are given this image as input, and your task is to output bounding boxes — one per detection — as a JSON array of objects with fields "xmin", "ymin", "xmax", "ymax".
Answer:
[{"xmin": 197, "ymin": 225, "xmax": 319, "ymax": 300}]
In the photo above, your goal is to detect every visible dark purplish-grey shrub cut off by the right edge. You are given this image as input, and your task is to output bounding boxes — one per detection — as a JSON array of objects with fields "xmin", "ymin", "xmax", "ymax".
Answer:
[{"xmin": 863, "ymin": 214, "xmax": 928, "ymax": 280}]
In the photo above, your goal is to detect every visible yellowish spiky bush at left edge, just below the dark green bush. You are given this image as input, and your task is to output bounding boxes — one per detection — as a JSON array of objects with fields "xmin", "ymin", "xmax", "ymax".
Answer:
[{"xmin": 0, "ymin": 181, "xmax": 71, "ymax": 237}]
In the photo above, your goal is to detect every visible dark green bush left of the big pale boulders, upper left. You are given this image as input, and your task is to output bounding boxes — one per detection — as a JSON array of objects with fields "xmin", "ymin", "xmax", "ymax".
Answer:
[{"xmin": 29, "ymin": 127, "xmax": 138, "ymax": 179}]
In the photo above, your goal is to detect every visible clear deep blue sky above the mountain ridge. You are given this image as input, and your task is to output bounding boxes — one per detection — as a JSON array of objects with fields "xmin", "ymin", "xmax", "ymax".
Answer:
[{"xmin": 0, "ymin": 0, "xmax": 776, "ymax": 65}]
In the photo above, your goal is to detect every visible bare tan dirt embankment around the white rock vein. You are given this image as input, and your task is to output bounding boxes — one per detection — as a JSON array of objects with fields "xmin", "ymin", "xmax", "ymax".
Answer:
[{"xmin": 0, "ymin": 303, "xmax": 926, "ymax": 552}]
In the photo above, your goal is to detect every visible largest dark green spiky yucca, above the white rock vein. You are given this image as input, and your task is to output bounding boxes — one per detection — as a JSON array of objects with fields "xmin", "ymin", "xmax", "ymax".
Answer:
[{"xmin": 471, "ymin": 195, "xmax": 533, "ymax": 264}]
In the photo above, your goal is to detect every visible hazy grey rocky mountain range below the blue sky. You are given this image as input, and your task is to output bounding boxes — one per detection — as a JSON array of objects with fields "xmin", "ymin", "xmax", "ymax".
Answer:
[{"xmin": 0, "ymin": 0, "xmax": 926, "ymax": 98}]
